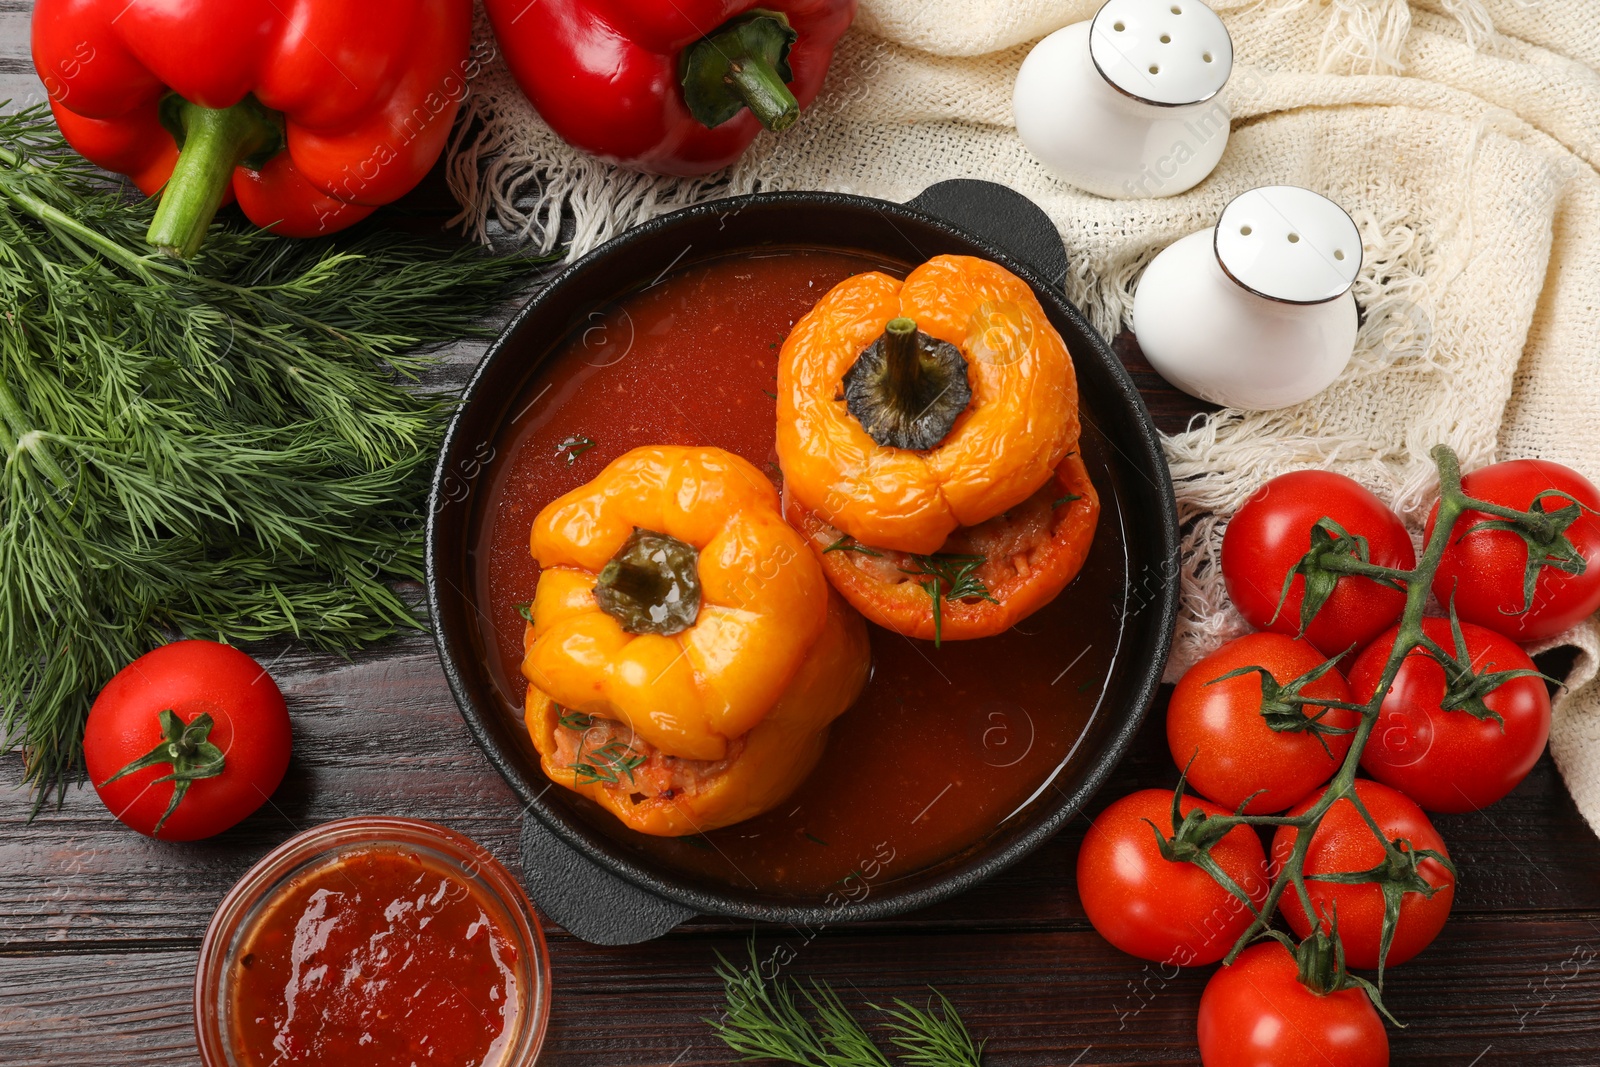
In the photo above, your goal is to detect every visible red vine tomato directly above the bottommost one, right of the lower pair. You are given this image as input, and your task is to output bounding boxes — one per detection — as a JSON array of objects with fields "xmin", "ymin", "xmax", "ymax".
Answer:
[{"xmin": 1272, "ymin": 779, "xmax": 1456, "ymax": 968}]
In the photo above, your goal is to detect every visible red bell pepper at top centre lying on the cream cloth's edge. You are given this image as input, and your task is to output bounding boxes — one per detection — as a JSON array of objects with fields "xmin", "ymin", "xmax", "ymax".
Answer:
[{"xmin": 485, "ymin": 0, "xmax": 856, "ymax": 174}]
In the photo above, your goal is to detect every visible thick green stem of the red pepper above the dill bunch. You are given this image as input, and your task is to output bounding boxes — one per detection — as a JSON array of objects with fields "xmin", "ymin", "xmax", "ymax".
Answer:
[{"xmin": 146, "ymin": 99, "xmax": 278, "ymax": 259}]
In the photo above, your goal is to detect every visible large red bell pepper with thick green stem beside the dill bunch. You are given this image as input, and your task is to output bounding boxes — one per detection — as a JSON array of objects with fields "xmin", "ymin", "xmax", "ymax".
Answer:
[{"xmin": 34, "ymin": 0, "xmax": 472, "ymax": 256}]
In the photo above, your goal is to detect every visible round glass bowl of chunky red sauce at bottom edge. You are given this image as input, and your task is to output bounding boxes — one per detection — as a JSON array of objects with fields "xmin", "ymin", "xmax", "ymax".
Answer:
[{"xmin": 195, "ymin": 819, "xmax": 549, "ymax": 1067}]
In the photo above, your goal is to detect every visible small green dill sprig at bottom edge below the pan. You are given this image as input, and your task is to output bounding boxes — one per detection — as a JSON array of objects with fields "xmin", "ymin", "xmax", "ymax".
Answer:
[{"xmin": 706, "ymin": 942, "xmax": 982, "ymax": 1067}]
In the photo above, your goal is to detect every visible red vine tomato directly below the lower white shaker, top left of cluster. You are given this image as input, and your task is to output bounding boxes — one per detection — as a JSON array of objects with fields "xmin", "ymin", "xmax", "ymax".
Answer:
[{"xmin": 1222, "ymin": 470, "xmax": 1416, "ymax": 656}]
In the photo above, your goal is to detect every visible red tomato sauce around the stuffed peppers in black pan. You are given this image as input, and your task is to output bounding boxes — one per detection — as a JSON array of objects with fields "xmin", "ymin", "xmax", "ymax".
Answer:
[{"xmin": 474, "ymin": 250, "xmax": 1126, "ymax": 899}]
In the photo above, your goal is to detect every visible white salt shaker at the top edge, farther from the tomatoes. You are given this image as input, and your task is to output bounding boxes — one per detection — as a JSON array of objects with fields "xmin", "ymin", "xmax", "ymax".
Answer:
[{"xmin": 1011, "ymin": 0, "xmax": 1234, "ymax": 200}]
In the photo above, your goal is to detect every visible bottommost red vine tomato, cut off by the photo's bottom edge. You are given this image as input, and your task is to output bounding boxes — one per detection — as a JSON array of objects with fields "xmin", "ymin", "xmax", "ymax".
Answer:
[{"xmin": 1200, "ymin": 941, "xmax": 1389, "ymax": 1067}]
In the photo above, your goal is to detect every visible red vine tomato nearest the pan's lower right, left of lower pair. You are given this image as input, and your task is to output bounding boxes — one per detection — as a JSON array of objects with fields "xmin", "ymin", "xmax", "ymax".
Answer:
[{"xmin": 1078, "ymin": 789, "xmax": 1267, "ymax": 966}]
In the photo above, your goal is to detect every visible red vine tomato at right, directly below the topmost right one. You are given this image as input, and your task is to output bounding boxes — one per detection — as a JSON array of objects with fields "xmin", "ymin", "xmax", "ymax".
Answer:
[{"xmin": 1350, "ymin": 619, "xmax": 1550, "ymax": 811}]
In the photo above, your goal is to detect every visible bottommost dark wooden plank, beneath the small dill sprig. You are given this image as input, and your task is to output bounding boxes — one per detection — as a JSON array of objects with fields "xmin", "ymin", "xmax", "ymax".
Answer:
[{"xmin": 0, "ymin": 913, "xmax": 1600, "ymax": 1067}]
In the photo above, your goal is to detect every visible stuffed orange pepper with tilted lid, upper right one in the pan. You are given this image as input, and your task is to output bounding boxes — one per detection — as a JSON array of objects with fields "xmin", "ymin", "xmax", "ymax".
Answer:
[{"xmin": 778, "ymin": 256, "xmax": 1099, "ymax": 641}]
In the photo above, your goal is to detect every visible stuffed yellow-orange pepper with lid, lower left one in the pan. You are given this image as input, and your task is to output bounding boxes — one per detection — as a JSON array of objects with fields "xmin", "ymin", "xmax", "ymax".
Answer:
[{"xmin": 523, "ymin": 446, "xmax": 869, "ymax": 835}]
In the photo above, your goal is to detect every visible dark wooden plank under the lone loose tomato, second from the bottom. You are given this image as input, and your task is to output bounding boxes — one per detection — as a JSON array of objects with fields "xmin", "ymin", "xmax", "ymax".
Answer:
[{"xmin": 0, "ymin": 633, "xmax": 1600, "ymax": 950}]
